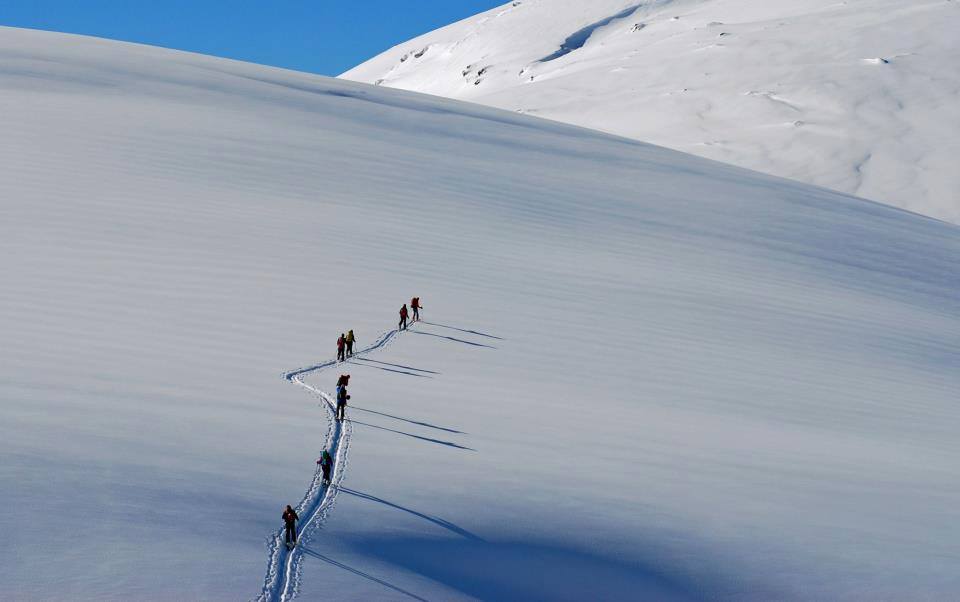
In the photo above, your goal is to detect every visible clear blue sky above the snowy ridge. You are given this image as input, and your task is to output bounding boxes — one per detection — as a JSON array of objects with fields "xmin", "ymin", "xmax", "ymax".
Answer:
[{"xmin": 0, "ymin": 0, "xmax": 507, "ymax": 75}]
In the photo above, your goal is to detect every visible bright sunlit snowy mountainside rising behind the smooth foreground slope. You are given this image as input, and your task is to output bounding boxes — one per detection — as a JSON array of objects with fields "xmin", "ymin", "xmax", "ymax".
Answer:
[{"xmin": 341, "ymin": 0, "xmax": 960, "ymax": 223}]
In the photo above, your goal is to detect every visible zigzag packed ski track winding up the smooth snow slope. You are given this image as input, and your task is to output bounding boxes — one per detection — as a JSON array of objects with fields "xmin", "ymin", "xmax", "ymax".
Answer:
[{"xmin": 257, "ymin": 324, "xmax": 402, "ymax": 602}]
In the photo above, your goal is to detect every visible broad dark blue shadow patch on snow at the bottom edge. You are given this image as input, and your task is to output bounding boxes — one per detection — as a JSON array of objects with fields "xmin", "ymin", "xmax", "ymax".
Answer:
[{"xmin": 349, "ymin": 536, "xmax": 700, "ymax": 602}]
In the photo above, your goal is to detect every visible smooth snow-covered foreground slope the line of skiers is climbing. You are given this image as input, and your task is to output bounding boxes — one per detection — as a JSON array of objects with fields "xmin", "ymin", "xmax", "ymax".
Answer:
[{"xmin": 0, "ymin": 24, "xmax": 960, "ymax": 600}]
